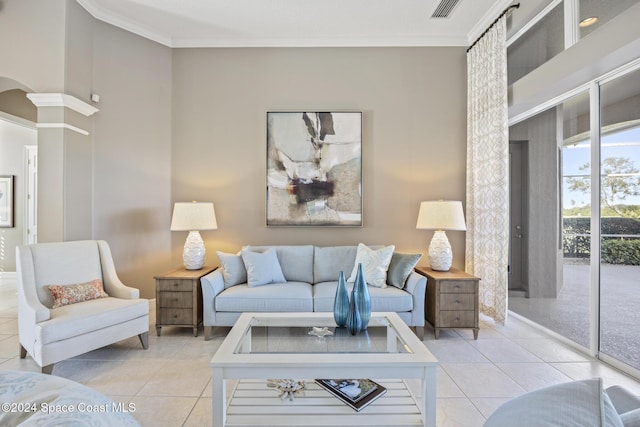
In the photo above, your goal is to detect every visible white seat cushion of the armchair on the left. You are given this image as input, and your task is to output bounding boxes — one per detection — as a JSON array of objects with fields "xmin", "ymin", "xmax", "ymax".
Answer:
[{"xmin": 36, "ymin": 297, "xmax": 149, "ymax": 344}]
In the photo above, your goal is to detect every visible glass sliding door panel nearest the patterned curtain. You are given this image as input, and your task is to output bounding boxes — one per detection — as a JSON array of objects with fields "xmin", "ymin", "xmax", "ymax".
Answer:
[{"xmin": 509, "ymin": 93, "xmax": 591, "ymax": 347}]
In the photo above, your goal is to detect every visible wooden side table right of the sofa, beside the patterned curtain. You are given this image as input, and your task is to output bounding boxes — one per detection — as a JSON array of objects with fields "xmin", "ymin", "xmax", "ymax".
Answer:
[{"xmin": 416, "ymin": 267, "xmax": 480, "ymax": 340}]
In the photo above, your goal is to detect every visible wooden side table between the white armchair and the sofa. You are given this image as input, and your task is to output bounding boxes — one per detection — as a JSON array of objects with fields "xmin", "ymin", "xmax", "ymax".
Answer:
[{"xmin": 154, "ymin": 266, "xmax": 216, "ymax": 337}]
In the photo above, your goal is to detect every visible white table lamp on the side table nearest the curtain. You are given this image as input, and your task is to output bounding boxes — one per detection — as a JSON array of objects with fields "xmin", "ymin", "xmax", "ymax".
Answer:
[{"xmin": 416, "ymin": 200, "xmax": 467, "ymax": 271}]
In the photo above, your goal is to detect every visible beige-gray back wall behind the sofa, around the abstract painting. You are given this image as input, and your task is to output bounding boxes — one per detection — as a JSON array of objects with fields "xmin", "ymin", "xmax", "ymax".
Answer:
[{"xmin": 167, "ymin": 48, "xmax": 466, "ymax": 274}]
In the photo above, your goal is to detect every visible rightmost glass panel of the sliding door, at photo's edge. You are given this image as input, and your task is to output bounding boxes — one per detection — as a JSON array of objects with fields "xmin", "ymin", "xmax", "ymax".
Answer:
[{"xmin": 599, "ymin": 71, "xmax": 640, "ymax": 370}]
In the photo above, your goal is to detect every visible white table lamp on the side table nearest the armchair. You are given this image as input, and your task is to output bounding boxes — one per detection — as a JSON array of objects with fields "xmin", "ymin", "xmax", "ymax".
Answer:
[{"xmin": 171, "ymin": 202, "xmax": 218, "ymax": 270}]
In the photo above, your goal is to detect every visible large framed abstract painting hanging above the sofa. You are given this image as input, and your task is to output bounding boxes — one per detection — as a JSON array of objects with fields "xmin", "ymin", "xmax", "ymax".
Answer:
[{"xmin": 267, "ymin": 112, "xmax": 362, "ymax": 227}]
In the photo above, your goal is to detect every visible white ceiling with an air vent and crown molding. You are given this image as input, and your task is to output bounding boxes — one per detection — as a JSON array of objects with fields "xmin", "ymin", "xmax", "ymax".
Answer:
[{"xmin": 77, "ymin": 0, "xmax": 512, "ymax": 47}]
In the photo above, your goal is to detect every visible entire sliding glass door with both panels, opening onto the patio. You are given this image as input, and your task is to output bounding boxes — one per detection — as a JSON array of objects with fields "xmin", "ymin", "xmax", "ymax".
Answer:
[{"xmin": 509, "ymin": 65, "xmax": 640, "ymax": 375}]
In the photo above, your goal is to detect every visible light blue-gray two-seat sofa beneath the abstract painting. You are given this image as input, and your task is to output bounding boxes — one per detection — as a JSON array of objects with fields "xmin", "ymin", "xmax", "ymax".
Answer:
[{"xmin": 200, "ymin": 245, "xmax": 427, "ymax": 340}]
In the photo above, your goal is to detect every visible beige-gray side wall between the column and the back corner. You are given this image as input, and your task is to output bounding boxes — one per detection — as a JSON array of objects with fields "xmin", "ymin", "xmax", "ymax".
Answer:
[{"xmin": 92, "ymin": 22, "xmax": 174, "ymax": 298}]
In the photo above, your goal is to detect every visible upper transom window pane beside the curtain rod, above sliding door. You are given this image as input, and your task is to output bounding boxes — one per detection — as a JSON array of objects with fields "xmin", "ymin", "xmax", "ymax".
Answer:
[{"xmin": 507, "ymin": 3, "xmax": 564, "ymax": 84}]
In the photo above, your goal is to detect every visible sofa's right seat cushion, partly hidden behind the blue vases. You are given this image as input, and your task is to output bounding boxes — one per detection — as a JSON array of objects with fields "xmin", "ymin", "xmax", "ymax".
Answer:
[{"xmin": 313, "ymin": 281, "xmax": 413, "ymax": 312}]
